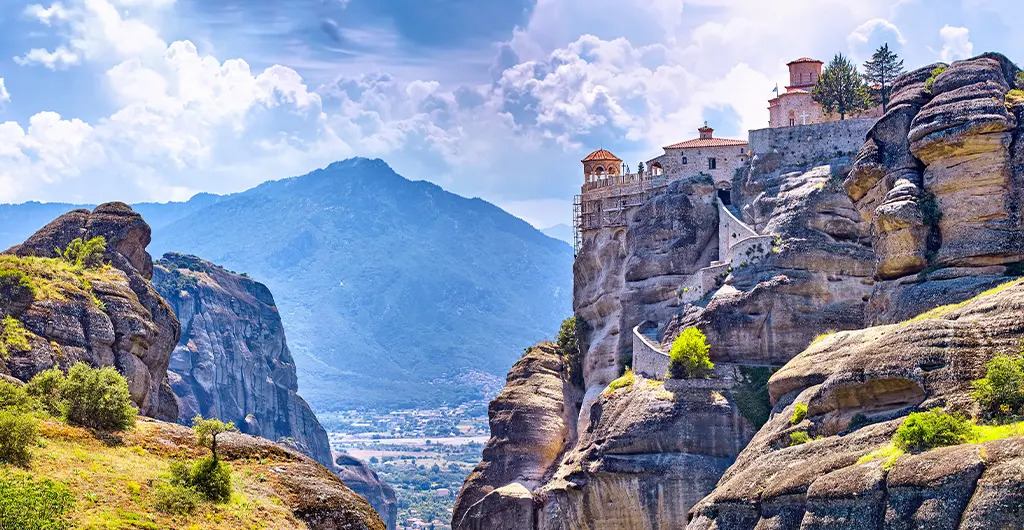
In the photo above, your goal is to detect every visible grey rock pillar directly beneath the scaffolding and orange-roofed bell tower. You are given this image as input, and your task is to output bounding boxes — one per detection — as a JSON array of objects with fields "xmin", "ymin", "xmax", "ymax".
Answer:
[{"xmin": 572, "ymin": 177, "xmax": 718, "ymax": 428}]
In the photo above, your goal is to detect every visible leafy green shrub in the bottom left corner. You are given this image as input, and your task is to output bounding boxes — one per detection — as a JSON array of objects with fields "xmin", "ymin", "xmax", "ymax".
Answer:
[{"xmin": 0, "ymin": 473, "xmax": 75, "ymax": 530}]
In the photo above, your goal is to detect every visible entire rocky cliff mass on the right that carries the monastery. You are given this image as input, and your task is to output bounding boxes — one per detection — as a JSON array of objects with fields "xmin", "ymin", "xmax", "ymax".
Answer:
[{"xmin": 453, "ymin": 54, "xmax": 1024, "ymax": 530}]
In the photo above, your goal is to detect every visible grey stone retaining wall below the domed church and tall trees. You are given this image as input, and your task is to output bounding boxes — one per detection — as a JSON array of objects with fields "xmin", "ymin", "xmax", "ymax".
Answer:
[{"xmin": 750, "ymin": 118, "xmax": 878, "ymax": 166}]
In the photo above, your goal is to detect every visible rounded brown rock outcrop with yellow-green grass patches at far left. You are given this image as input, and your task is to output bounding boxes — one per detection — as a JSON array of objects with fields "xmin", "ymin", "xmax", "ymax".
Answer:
[{"xmin": 4, "ymin": 203, "xmax": 181, "ymax": 421}]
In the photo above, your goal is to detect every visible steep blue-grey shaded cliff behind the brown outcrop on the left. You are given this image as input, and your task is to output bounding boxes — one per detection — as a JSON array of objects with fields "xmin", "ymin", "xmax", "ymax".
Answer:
[{"xmin": 154, "ymin": 254, "xmax": 397, "ymax": 529}]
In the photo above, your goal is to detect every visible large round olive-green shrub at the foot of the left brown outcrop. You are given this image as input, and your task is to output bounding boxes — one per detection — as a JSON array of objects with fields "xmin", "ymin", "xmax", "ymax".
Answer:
[{"xmin": 60, "ymin": 362, "xmax": 138, "ymax": 431}]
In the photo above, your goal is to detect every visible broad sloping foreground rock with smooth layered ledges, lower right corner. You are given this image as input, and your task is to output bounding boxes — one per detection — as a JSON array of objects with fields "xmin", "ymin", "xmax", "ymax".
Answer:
[{"xmin": 687, "ymin": 280, "xmax": 1024, "ymax": 530}]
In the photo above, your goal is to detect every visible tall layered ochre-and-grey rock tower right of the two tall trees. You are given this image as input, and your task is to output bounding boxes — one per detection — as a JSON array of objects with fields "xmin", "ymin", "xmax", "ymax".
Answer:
[{"xmin": 845, "ymin": 53, "xmax": 1024, "ymax": 323}]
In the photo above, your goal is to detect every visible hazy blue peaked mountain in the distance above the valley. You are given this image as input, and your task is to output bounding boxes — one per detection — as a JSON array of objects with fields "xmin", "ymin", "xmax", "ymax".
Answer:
[{"xmin": 147, "ymin": 159, "xmax": 572, "ymax": 408}]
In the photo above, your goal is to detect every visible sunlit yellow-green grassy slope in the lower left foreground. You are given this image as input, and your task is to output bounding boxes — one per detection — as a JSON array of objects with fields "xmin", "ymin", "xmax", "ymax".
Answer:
[{"xmin": 9, "ymin": 418, "xmax": 305, "ymax": 530}]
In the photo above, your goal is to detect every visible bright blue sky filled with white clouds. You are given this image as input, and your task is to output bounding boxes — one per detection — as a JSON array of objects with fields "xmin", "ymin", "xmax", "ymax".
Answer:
[{"xmin": 0, "ymin": 0, "xmax": 1024, "ymax": 227}]
